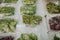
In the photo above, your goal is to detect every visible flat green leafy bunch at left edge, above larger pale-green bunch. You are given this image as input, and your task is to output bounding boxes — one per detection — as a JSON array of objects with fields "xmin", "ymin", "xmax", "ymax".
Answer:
[{"xmin": 0, "ymin": 7, "xmax": 15, "ymax": 16}]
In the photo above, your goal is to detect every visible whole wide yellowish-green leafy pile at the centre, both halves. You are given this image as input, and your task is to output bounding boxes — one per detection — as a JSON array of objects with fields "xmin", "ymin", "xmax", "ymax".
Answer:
[{"xmin": 23, "ymin": 15, "xmax": 42, "ymax": 25}]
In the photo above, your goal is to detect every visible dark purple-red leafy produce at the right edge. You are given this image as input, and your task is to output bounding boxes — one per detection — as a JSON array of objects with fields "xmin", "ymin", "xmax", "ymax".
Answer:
[{"xmin": 49, "ymin": 16, "xmax": 60, "ymax": 31}]
